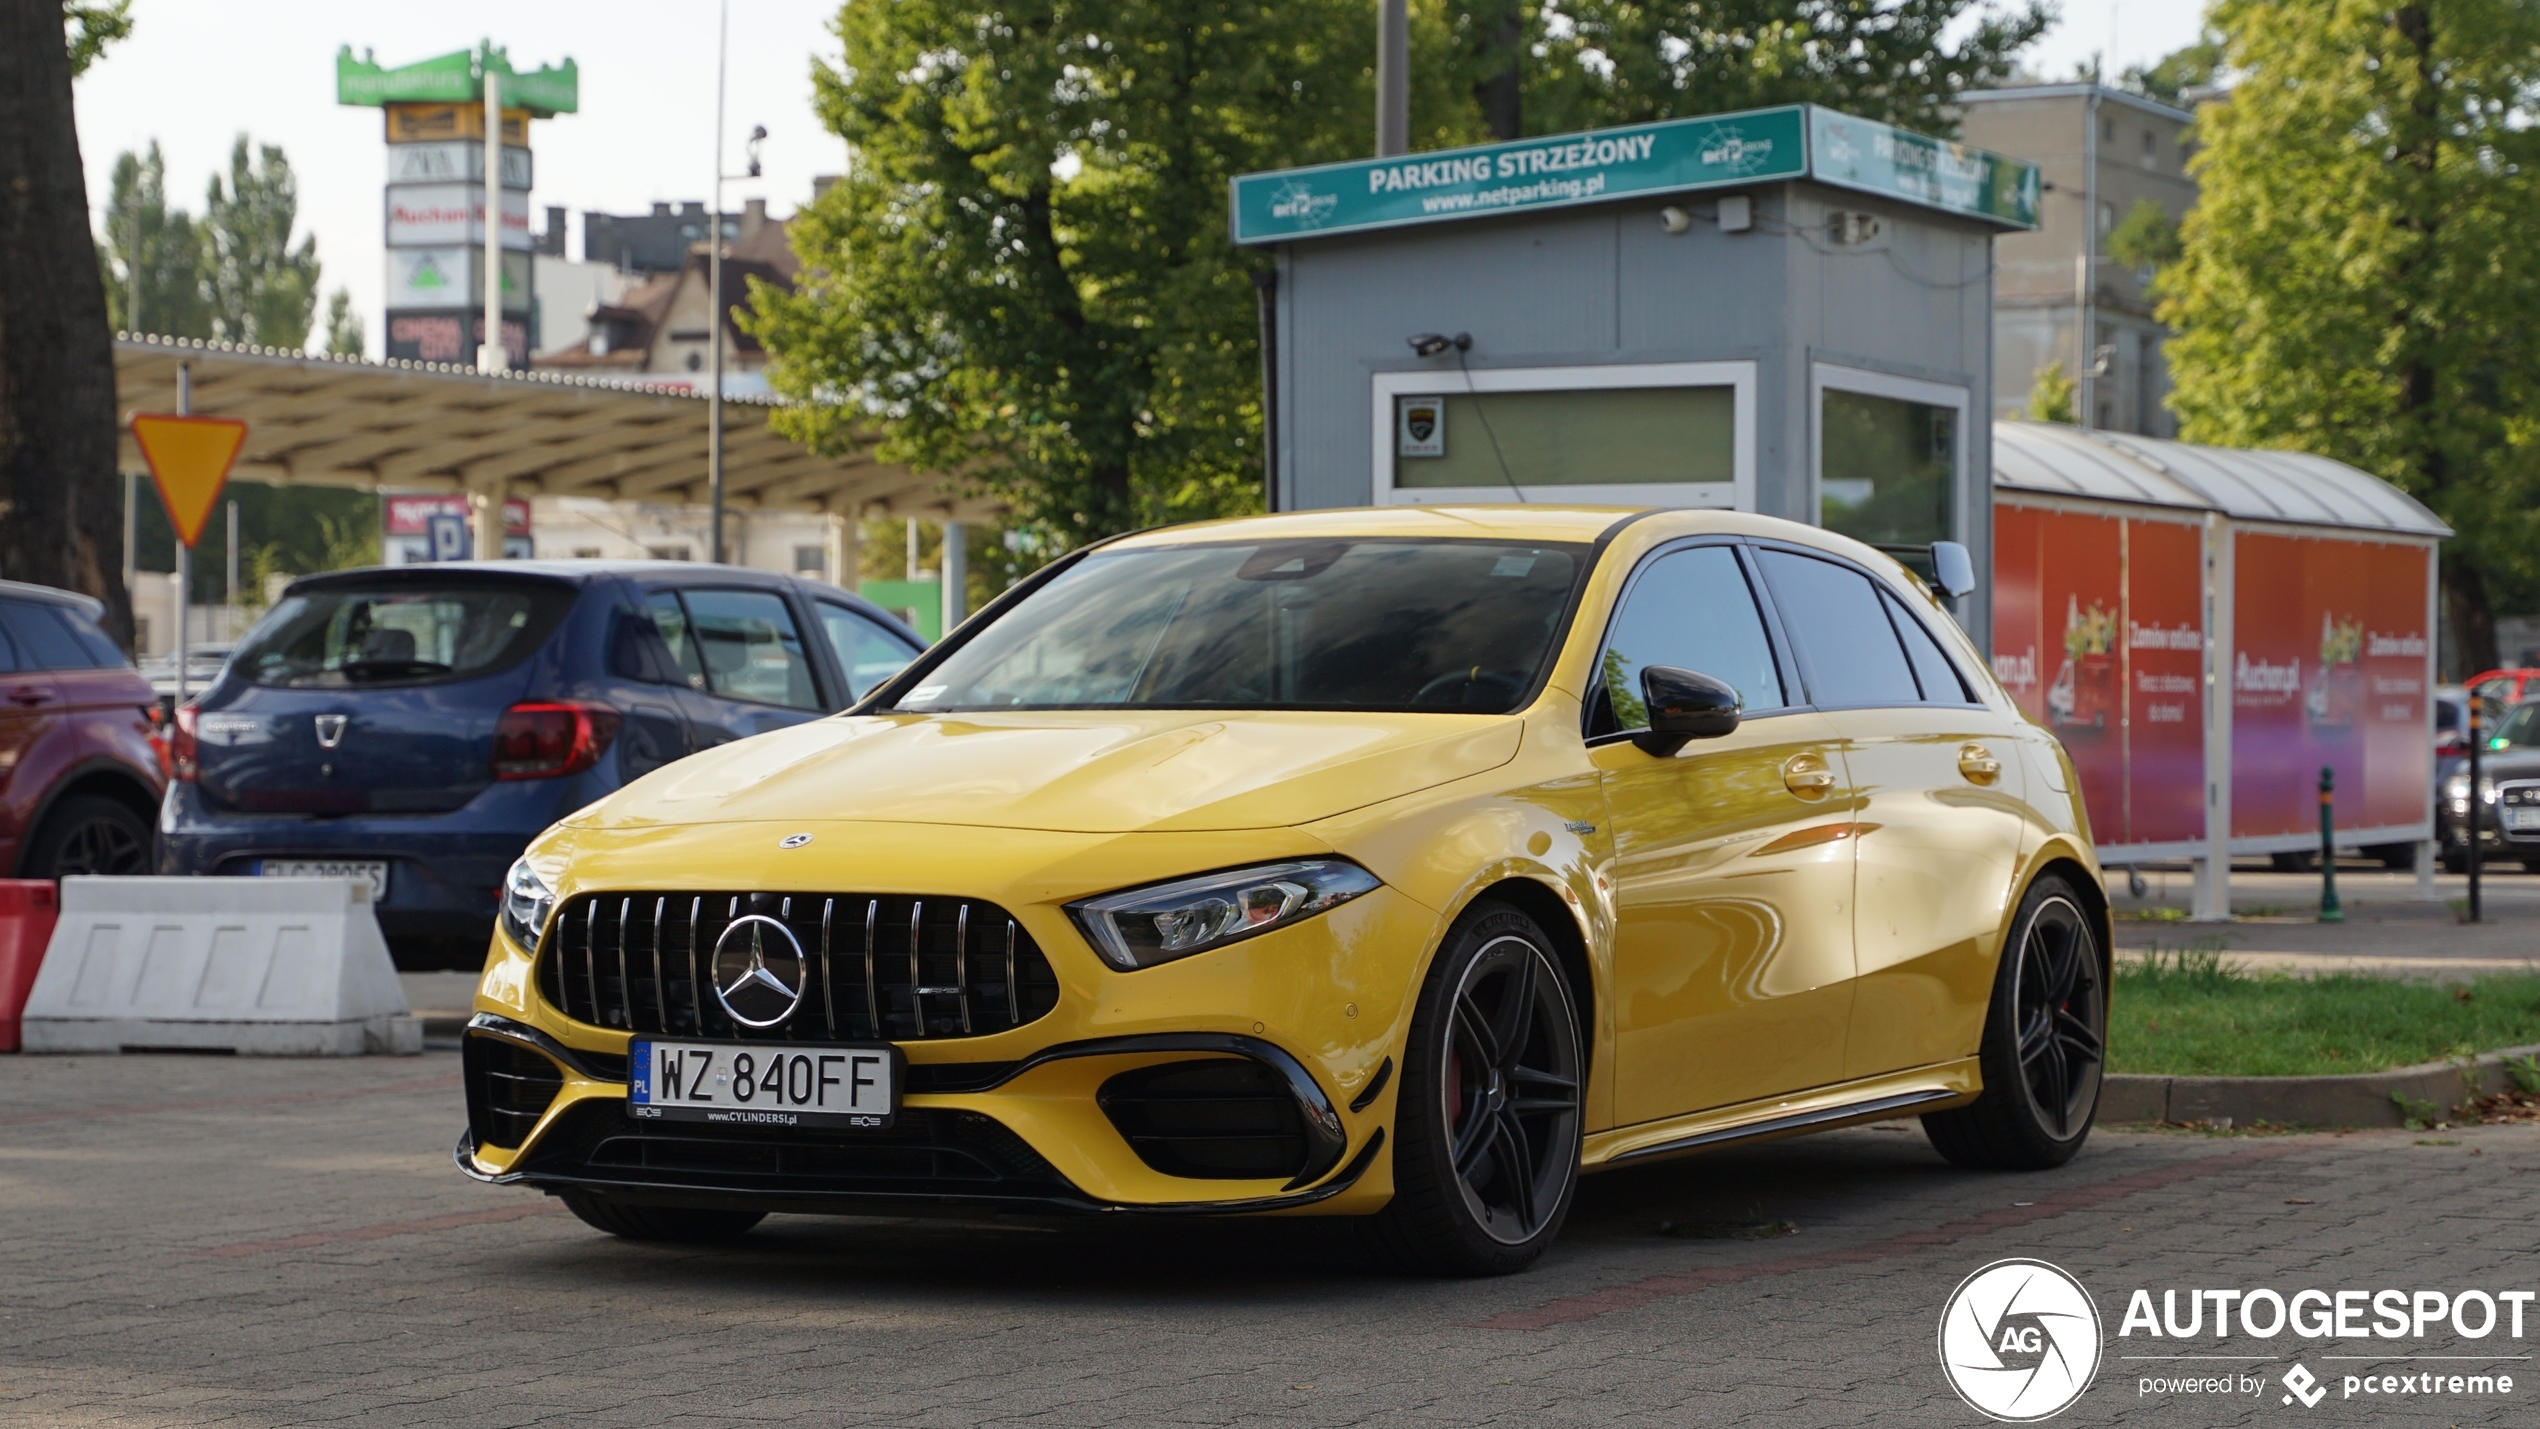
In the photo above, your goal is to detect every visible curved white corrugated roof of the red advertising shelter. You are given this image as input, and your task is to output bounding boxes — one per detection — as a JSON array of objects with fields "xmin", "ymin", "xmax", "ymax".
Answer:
[{"xmin": 1994, "ymin": 421, "xmax": 2451, "ymax": 541}]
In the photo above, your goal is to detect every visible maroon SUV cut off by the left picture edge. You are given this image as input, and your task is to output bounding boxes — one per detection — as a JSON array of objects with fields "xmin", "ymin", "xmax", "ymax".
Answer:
[{"xmin": 0, "ymin": 581, "xmax": 168, "ymax": 878}]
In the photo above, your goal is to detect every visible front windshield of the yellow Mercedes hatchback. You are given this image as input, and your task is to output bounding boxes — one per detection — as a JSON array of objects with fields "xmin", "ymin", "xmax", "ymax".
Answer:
[{"xmin": 894, "ymin": 541, "xmax": 1588, "ymax": 713}]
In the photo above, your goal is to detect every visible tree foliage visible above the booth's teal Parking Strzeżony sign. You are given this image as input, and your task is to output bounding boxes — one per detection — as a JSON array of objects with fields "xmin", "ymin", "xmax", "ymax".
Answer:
[{"xmin": 1527, "ymin": 0, "xmax": 2055, "ymax": 135}]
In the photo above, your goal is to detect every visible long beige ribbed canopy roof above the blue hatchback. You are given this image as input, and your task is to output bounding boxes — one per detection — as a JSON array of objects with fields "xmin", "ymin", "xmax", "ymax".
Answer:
[{"xmin": 114, "ymin": 333, "xmax": 998, "ymax": 520}]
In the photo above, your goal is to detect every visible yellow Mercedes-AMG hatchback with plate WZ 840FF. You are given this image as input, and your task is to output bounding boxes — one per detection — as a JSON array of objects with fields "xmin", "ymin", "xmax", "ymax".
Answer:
[{"xmin": 457, "ymin": 508, "xmax": 2108, "ymax": 1274}]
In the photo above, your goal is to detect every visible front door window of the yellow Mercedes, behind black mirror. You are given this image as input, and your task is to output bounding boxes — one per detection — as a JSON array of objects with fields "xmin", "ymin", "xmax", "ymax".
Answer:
[{"xmin": 1588, "ymin": 546, "xmax": 1791, "ymax": 736}]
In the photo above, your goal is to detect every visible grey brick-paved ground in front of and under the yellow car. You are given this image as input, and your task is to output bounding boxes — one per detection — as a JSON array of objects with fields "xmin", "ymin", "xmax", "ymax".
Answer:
[{"xmin": 0, "ymin": 1053, "xmax": 2540, "ymax": 1426}]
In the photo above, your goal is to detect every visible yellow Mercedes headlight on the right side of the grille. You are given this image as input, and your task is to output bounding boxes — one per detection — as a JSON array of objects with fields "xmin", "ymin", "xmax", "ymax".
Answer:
[{"xmin": 1067, "ymin": 858, "xmax": 1379, "ymax": 972}]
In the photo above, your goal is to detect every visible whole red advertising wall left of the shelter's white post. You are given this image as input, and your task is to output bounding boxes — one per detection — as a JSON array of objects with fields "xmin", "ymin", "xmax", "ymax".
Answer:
[{"xmin": 1994, "ymin": 505, "xmax": 2205, "ymax": 848}]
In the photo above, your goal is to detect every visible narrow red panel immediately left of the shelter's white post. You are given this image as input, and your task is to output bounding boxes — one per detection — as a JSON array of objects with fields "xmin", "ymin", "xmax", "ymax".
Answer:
[{"xmin": 2123, "ymin": 520, "xmax": 2205, "ymax": 843}]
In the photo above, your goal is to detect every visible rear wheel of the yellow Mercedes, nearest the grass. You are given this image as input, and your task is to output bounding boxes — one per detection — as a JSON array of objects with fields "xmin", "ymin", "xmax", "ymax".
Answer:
[{"xmin": 1923, "ymin": 873, "xmax": 2108, "ymax": 1170}]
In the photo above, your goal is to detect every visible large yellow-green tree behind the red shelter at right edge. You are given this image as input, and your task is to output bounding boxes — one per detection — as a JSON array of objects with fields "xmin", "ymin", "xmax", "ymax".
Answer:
[{"xmin": 2162, "ymin": 0, "xmax": 2540, "ymax": 665}]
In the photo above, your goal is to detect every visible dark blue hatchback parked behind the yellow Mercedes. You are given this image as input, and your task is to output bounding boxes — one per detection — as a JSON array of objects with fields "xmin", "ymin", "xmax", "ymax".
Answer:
[{"xmin": 160, "ymin": 561, "xmax": 922, "ymax": 970}]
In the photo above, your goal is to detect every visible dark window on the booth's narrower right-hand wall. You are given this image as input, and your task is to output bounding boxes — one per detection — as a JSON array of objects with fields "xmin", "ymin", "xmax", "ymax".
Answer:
[{"xmin": 1816, "ymin": 386, "xmax": 1963, "ymax": 546}]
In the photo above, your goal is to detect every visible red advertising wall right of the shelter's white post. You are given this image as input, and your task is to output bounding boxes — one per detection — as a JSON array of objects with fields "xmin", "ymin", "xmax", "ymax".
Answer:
[{"xmin": 2230, "ymin": 530, "xmax": 2433, "ymax": 838}]
